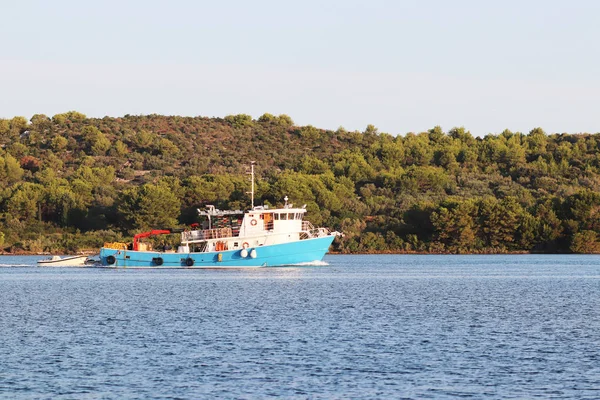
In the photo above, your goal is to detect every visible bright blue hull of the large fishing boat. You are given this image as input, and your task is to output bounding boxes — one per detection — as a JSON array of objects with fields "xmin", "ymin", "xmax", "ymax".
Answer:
[{"xmin": 100, "ymin": 235, "xmax": 335, "ymax": 268}]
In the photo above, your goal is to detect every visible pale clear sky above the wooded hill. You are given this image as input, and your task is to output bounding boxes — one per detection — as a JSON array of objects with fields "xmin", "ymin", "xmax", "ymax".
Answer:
[{"xmin": 0, "ymin": 0, "xmax": 600, "ymax": 135}]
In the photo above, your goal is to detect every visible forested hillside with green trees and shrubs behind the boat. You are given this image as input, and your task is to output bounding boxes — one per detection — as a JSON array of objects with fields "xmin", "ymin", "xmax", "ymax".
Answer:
[{"xmin": 0, "ymin": 112, "xmax": 600, "ymax": 253}]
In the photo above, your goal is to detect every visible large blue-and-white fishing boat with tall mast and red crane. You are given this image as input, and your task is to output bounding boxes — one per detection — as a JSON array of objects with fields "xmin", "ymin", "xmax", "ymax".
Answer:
[{"xmin": 100, "ymin": 164, "xmax": 341, "ymax": 268}]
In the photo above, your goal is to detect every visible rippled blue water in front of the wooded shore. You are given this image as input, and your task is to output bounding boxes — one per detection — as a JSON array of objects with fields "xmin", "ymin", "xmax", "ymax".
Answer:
[{"xmin": 0, "ymin": 255, "xmax": 600, "ymax": 399}]
